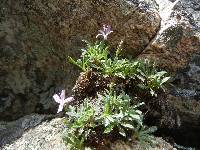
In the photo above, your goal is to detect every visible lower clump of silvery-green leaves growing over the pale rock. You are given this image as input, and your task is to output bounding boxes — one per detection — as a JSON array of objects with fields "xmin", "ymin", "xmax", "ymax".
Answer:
[{"xmin": 64, "ymin": 89, "xmax": 154, "ymax": 150}]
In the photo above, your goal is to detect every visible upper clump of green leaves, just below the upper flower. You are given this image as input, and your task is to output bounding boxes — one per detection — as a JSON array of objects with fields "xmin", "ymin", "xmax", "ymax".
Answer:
[{"xmin": 69, "ymin": 41, "xmax": 170, "ymax": 96}]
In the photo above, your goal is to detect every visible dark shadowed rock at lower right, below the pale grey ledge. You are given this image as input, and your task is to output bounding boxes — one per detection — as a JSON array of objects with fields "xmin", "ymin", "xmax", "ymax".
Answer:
[{"xmin": 165, "ymin": 95, "xmax": 200, "ymax": 149}]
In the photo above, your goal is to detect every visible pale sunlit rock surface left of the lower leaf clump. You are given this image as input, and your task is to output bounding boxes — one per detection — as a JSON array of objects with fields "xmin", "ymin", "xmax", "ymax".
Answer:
[{"xmin": 2, "ymin": 118, "xmax": 66, "ymax": 150}]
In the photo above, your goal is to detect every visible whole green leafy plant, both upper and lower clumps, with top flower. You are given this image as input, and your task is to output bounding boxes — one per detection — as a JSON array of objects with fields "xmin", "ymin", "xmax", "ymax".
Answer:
[{"xmin": 59, "ymin": 25, "xmax": 170, "ymax": 150}]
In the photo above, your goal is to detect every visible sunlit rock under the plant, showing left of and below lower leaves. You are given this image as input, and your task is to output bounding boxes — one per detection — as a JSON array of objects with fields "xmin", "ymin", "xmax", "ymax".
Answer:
[{"xmin": 2, "ymin": 115, "xmax": 176, "ymax": 150}]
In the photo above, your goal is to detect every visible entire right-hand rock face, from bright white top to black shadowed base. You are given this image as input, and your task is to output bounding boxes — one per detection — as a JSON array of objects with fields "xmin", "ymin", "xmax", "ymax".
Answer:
[{"xmin": 141, "ymin": 0, "xmax": 200, "ymax": 147}]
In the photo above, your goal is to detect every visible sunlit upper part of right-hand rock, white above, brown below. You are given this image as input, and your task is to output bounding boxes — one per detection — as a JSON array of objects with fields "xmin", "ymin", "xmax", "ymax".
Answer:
[{"xmin": 142, "ymin": 0, "xmax": 200, "ymax": 71}]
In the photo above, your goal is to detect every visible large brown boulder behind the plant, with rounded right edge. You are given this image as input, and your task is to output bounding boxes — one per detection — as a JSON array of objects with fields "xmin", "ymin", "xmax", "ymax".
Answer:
[{"xmin": 0, "ymin": 0, "xmax": 160, "ymax": 120}]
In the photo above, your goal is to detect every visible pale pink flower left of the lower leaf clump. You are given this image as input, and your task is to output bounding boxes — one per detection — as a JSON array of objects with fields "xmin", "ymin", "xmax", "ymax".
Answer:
[{"xmin": 53, "ymin": 90, "xmax": 74, "ymax": 113}]
